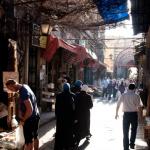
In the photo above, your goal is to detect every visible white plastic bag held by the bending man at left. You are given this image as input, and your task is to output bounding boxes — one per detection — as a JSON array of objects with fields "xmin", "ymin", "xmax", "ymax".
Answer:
[{"xmin": 16, "ymin": 125, "xmax": 25, "ymax": 149}]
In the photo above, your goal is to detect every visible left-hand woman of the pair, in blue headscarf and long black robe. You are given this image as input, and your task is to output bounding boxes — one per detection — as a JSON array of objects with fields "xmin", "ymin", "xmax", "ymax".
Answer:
[{"xmin": 54, "ymin": 83, "xmax": 75, "ymax": 150}]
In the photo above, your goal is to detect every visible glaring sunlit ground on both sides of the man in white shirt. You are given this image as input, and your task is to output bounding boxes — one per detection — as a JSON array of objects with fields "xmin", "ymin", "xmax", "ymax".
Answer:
[{"xmin": 81, "ymin": 101, "xmax": 147, "ymax": 150}]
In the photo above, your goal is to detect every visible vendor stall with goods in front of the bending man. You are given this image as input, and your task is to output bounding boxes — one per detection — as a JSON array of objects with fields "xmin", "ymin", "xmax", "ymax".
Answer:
[{"xmin": 0, "ymin": 93, "xmax": 24, "ymax": 150}]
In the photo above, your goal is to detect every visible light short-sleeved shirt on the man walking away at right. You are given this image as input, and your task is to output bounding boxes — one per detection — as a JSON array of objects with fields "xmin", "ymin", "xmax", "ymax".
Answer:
[{"xmin": 117, "ymin": 90, "xmax": 142, "ymax": 112}]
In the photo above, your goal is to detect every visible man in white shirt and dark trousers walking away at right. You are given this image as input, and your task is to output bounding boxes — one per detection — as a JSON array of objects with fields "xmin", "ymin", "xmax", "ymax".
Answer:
[{"xmin": 115, "ymin": 83, "xmax": 142, "ymax": 150}]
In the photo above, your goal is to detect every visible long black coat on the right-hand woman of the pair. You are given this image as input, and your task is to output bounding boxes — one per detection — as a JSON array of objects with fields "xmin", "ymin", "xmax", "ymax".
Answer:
[{"xmin": 75, "ymin": 91, "xmax": 93, "ymax": 139}]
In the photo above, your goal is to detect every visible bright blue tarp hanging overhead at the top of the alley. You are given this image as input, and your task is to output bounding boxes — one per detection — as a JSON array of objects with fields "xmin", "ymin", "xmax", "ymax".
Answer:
[{"xmin": 95, "ymin": 0, "xmax": 129, "ymax": 24}]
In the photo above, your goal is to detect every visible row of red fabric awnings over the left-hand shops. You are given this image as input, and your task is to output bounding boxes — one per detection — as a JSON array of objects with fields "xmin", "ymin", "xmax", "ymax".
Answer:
[{"xmin": 42, "ymin": 35, "xmax": 104, "ymax": 67}]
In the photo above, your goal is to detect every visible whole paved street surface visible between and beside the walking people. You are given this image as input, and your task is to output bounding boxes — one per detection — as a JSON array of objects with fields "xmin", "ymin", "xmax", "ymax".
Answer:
[{"xmin": 40, "ymin": 99, "xmax": 148, "ymax": 150}]
